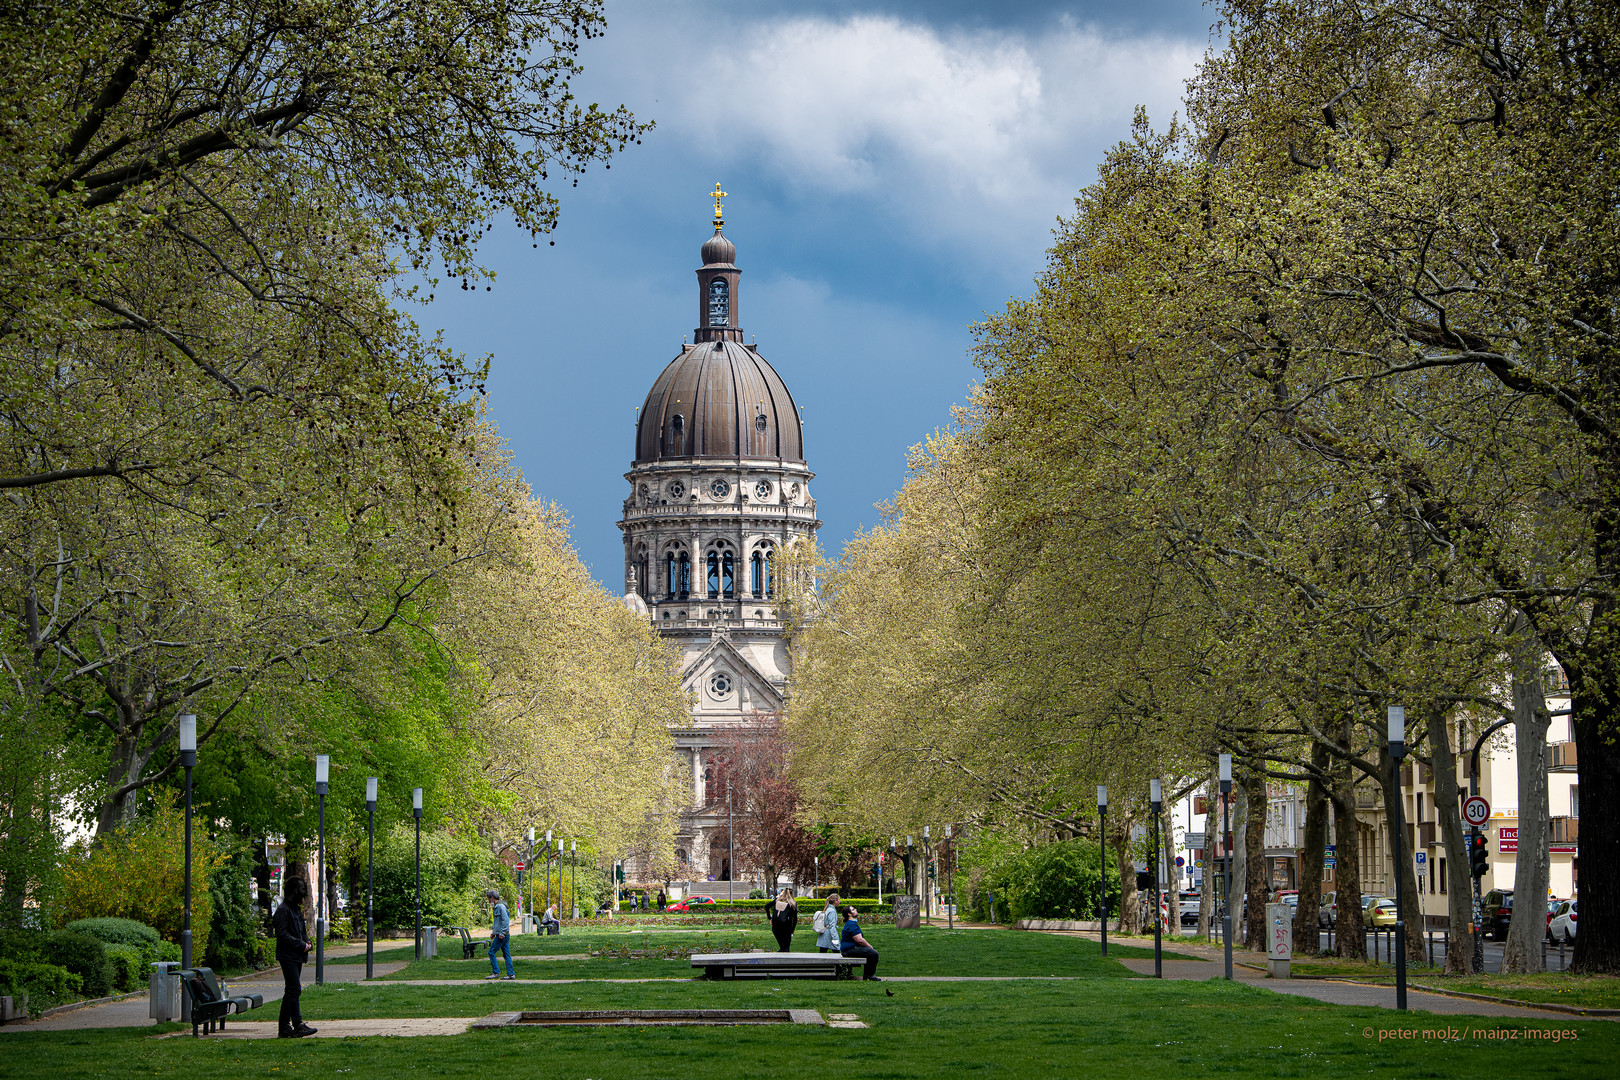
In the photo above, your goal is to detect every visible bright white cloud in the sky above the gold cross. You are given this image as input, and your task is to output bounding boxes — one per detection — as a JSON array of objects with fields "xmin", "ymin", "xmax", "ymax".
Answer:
[{"xmin": 592, "ymin": 3, "xmax": 1204, "ymax": 263}]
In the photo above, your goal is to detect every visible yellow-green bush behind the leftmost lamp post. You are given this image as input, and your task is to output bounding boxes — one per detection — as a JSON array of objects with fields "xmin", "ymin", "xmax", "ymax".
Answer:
[{"xmin": 58, "ymin": 806, "xmax": 222, "ymax": 958}]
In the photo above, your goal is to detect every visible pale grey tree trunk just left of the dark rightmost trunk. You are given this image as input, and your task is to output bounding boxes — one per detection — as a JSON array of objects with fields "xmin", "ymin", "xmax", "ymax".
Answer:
[{"xmin": 1502, "ymin": 617, "xmax": 1548, "ymax": 973}]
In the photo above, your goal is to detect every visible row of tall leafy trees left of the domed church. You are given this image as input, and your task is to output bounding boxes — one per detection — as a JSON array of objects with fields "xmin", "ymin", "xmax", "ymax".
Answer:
[{"xmin": 0, "ymin": 0, "xmax": 684, "ymax": 921}]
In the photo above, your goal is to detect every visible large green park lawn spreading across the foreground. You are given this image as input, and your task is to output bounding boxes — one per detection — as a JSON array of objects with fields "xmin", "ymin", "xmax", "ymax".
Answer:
[{"xmin": 0, "ymin": 928, "xmax": 1620, "ymax": 1080}]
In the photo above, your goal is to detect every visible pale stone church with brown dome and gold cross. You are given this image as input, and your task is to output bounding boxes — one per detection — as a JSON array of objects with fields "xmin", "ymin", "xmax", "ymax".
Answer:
[{"xmin": 619, "ymin": 198, "xmax": 821, "ymax": 895}]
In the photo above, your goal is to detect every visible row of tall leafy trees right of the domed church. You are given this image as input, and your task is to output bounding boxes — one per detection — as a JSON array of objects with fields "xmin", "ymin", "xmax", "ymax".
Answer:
[{"xmin": 791, "ymin": 0, "xmax": 1620, "ymax": 972}]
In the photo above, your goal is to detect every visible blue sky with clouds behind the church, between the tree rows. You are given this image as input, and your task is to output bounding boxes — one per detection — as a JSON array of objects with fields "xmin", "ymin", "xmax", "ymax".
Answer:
[{"xmin": 416, "ymin": 0, "xmax": 1215, "ymax": 591}]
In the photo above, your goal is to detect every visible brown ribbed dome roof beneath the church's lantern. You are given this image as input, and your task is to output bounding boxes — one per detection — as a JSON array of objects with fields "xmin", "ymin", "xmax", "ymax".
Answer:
[{"xmin": 635, "ymin": 342, "xmax": 805, "ymax": 465}]
